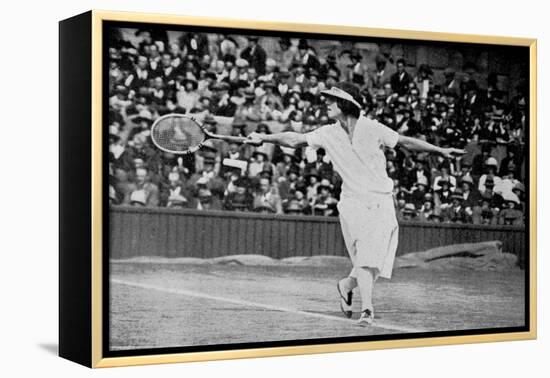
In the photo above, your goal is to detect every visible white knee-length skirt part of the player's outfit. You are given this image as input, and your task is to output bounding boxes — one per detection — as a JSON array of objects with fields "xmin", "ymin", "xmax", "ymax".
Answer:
[{"xmin": 338, "ymin": 194, "xmax": 399, "ymax": 278}]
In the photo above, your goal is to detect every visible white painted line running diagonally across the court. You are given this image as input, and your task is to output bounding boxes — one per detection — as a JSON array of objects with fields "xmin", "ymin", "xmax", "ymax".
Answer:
[{"xmin": 111, "ymin": 278, "xmax": 426, "ymax": 333}]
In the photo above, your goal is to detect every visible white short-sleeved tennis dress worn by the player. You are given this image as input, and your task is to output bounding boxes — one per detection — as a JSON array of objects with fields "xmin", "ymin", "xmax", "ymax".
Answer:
[{"xmin": 306, "ymin": 115, "xmax": 399, "ymax": 278}]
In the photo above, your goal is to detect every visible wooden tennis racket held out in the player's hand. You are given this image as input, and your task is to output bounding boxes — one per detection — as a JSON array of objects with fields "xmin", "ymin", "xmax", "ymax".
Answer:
[{"xmin": 151, "ymin": 113, "xmax": 261, "ymax": 155}]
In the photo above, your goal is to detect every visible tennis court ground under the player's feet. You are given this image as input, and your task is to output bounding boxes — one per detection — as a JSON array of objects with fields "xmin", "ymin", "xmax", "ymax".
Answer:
[{"xmin": 110, "ymin": 260, "xmax": 525, "ymax": 350}]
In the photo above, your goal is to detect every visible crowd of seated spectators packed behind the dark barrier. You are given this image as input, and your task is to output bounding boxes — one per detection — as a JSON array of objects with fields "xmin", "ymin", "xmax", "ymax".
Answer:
[{"xmin": 108, "ymin": 30, "xmax": 526, "ymax": 225}]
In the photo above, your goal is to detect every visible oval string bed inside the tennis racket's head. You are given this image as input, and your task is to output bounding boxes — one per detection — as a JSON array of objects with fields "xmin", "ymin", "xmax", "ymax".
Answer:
[{"xmin": 151, "ymin": 117, "xmax": 205, "ymax": 153}]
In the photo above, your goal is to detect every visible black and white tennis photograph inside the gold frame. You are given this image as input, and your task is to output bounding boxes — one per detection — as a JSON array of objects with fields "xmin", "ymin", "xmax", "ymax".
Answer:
[{"xmin": 102, "ymin": 21, "xmax": 530, "ymax": 356}]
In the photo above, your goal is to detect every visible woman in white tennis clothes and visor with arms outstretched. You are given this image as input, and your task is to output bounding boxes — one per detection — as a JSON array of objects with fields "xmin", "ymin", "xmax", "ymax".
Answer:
[{"xmin": 248, "ymin": 83, "xmax": 464, "ymax": 326}]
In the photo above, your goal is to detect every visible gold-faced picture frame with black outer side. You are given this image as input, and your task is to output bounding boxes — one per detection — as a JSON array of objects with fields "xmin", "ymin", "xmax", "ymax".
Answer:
[{"xmin": 60, "ymin": 10, "xmax": 537, "ymax": 368}]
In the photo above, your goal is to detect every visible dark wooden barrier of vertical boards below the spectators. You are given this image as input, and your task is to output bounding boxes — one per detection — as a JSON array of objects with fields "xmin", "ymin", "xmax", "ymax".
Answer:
[{"xmin": 110, "ymin": 206, "xmax": 525, "ymax": 263}]
